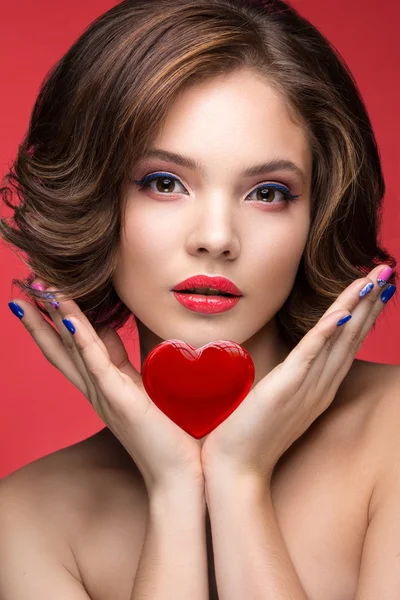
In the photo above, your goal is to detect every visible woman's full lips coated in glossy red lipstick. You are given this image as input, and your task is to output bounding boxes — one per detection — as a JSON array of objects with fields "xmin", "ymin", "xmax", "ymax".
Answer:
[{"xmin": 172, "ymin": 275, "xmax": 242, "ymax": 314}]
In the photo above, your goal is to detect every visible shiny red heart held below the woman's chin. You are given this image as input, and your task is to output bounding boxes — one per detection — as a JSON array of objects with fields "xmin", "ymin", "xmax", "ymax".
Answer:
[{"xmin": 142, "ymin": 340, "xmax": 254, "ymax": 439}]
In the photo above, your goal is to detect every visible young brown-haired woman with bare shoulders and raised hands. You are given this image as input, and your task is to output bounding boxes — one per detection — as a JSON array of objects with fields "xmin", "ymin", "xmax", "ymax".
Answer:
[{"xmin": 0, "ymin": 0, "xmax": 400, "ymax": 600}]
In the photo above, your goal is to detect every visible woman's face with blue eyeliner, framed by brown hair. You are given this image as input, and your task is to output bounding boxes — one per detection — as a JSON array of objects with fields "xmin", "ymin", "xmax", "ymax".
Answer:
[{"xmin": 113, "ymin": 70, "xmax": 312, "ymax": 360}]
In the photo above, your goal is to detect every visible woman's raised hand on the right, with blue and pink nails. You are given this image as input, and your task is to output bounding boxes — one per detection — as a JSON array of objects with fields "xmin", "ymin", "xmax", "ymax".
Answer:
[{"xmin": 201, "ymin": 265, "xmax": 396, "ymax": 484}]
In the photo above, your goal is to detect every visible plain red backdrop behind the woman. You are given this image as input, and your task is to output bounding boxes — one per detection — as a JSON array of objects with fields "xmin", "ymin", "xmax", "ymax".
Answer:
[{"xmin": 0, "ymin": 0, "xmax": 400, "ymax": 479}]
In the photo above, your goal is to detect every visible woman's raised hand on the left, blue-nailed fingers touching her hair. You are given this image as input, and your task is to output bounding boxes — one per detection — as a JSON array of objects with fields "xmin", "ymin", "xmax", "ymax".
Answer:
[{"xmin": 10, "ymin": 280, "xmax": 204, "ymax": 495}]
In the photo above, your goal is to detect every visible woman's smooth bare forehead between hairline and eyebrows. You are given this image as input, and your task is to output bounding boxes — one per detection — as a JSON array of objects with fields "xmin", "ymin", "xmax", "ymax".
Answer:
[{"xmin": 153, "ymin": 70, "xmax": 311, "ymax": 176}]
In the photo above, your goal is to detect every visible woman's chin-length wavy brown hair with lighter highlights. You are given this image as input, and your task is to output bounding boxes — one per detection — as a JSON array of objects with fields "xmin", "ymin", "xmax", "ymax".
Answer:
[{"xmin": 0, "ymin": 0, "xmax": 397, "ymax": 347}]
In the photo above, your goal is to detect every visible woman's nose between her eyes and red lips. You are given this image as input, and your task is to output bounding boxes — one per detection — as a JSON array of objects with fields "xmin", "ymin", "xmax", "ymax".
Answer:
[{"xmin": 186, "ymin": 196, "xmax": 240, "ymax": 260}]
